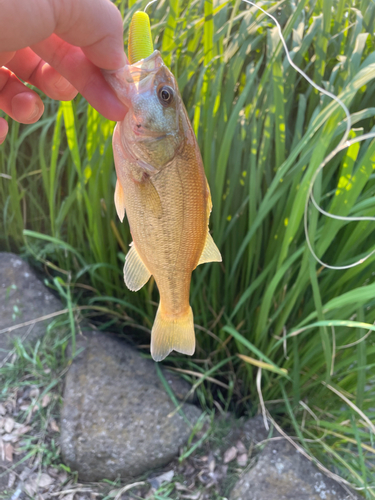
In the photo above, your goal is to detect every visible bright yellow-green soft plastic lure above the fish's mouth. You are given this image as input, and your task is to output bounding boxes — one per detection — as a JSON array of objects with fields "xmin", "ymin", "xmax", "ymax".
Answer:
[{"xmin": 128, "ymin": 11, "xmax": 154, "ymax": 64}]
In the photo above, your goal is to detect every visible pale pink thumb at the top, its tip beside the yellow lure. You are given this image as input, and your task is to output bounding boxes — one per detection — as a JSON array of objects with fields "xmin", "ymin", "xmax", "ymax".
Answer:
[{"xmin": 0, "ymin": 0, "xmax": 126, "ymax": 69}]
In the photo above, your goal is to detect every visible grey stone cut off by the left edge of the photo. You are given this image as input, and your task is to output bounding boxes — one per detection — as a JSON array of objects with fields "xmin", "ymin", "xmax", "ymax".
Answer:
[{"xmin": 0, "ymin": 252, "xmax": 63, "ymax": 364}]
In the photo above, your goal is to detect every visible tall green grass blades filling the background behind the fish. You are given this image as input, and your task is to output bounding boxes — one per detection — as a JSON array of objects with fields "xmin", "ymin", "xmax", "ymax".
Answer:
[{"xmin": 0, "ymin": 0, "xmax": 375, "ymax": 498}]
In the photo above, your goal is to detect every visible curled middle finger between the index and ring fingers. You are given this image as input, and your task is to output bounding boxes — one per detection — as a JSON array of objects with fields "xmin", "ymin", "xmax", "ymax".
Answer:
[{"xmin": 7, "ymin": 47, "xmax": 78, "ymax": 101}]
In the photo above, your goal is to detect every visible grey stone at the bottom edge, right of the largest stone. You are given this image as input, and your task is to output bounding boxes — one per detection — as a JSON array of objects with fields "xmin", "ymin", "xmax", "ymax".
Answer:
[{"xmin": 230, "ymin": 417, "xmax": 362, "ymax": 500}]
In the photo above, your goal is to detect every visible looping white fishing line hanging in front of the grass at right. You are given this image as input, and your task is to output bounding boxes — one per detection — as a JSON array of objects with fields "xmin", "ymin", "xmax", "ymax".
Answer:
[{"xmin": 242, "ymin": 0, "xmax": 375, "ymax": 270}]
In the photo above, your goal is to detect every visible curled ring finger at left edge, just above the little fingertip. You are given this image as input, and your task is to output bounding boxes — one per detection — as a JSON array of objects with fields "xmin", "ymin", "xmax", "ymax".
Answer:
[{"xmin": 0, "ymin": 68, "xmax": 44, "ymax": 123}]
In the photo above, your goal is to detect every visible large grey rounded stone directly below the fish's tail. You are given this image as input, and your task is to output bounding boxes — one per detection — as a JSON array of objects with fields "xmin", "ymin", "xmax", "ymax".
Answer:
[{"xmin": 61, "ymin": 332, "xmax": 201, "ymax": 481}]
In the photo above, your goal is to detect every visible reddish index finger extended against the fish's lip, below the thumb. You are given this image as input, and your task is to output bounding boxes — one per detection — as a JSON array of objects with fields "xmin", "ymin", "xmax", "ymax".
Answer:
[{"xmin": 32, "ymin": 35, "xmax": 127, "ymax": 121}]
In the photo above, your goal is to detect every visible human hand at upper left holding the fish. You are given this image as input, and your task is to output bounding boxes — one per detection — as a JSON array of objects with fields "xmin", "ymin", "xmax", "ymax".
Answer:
[{"xmin": 0, "ymin": 0, "xmax": 127, "ymax": 144}]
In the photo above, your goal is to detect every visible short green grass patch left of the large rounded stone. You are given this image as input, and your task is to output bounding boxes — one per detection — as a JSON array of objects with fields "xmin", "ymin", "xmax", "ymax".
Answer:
[{"xmin": 0, "ymin": 315, "xmax": 72, "ymax": 484}]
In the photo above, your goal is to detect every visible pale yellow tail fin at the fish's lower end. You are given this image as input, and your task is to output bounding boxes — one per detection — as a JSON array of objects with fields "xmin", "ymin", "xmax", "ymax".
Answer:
[{"xmin": 151, "ymin": 305, "xmax": 195, "ymax": 361}]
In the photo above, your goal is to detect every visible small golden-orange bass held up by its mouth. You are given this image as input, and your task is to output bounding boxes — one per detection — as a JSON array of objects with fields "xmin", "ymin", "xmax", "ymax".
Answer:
[{"xmin": 105, "ymin": 19, "xmax": 222, "ymax": 361}]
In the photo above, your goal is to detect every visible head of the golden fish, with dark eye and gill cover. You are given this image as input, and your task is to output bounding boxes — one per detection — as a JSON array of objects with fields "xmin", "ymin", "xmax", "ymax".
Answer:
[{"xmin": 105, "ymin": 51, "xmax": 184, "ymax": 172}]
